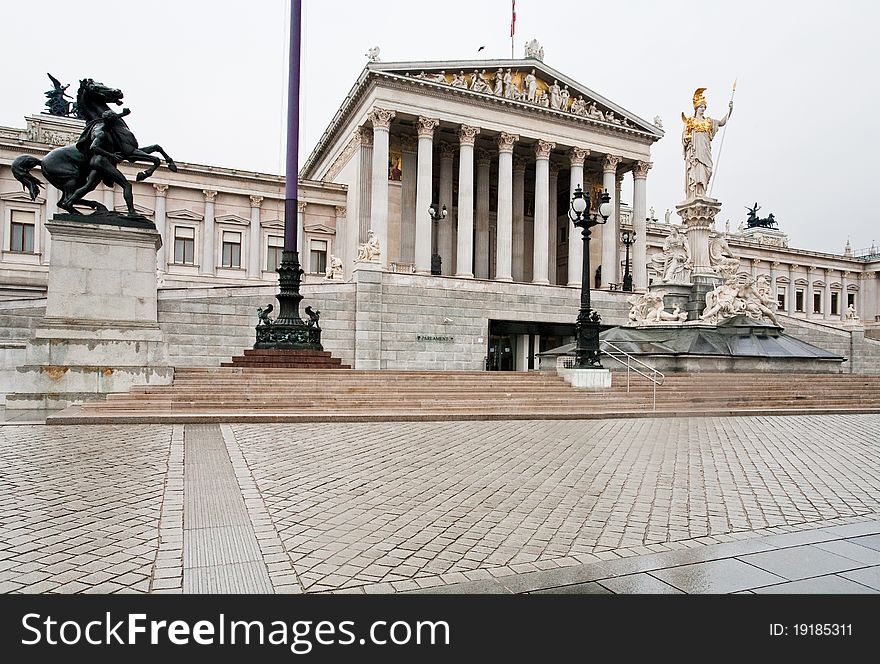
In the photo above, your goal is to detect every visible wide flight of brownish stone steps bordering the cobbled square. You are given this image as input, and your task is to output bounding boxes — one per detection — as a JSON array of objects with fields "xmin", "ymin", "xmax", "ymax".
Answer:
[{"xmin": 49, "ymin": 367, "xmax": 880, "ymax": 424}]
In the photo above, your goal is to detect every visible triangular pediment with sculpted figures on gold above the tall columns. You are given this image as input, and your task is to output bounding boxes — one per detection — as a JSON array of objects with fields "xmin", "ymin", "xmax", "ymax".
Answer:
[{"xmin": 367, "ymin": 59, "xmax": 663, "ymax": 138}]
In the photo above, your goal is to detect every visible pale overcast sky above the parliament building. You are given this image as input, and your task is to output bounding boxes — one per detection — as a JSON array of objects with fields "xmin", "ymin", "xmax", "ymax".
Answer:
[{"xmin": 0, "ymin": 0, "xmax": 880, "ymax": 253}]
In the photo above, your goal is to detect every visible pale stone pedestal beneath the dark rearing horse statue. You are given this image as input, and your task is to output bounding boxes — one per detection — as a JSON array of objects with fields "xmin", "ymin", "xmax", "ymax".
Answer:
[{"xmin": 6, "ymin": 214, "xmax": 174, "ymax": 408}]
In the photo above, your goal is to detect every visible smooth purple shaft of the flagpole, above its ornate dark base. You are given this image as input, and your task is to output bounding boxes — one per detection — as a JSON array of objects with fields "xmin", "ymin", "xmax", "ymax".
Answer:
[{"xmin": 284, "ymin": 0, "xmax": 302, "ymax": 251}]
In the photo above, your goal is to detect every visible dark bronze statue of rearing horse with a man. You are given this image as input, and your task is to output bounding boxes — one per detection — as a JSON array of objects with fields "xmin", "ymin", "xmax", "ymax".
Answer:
[{"xmin": 12, "ymin": 78, "xmax": 177, "ymax": 216}]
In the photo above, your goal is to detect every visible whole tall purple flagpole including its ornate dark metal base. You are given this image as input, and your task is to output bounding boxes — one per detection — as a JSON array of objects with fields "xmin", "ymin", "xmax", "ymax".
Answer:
[{"xmin": 254, "ymin": 0, "xmax": 324, "ymax": 351}]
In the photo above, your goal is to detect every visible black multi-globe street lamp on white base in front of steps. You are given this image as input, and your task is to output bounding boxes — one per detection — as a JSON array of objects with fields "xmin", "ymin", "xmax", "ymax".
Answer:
[{"xmin": 568, "ymin": 185, "xmax": 611, "ymax": 369}]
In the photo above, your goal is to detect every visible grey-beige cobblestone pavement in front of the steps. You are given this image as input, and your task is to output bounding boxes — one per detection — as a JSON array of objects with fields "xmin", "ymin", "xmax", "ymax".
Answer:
[{"xmin": 0, "ymin": 415, "xmax": 880, "ymax": 593}]
